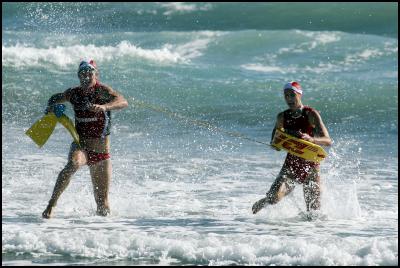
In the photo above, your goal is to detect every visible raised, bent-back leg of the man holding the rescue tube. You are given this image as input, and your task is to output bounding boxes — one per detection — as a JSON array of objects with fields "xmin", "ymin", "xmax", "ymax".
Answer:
[{"xmin": 252, "ymin": 172, "xmax": 294, "ymax": 214}]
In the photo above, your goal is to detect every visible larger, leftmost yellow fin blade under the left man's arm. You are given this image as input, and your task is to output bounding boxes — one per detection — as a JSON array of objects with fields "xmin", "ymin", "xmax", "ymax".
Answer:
[{"xmin": 25, "ymin": 113, "xmax": 57, "ymax": 148}]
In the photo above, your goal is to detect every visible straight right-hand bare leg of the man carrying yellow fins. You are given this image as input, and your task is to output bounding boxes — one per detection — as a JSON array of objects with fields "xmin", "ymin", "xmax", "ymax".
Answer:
[{"xmin": 89, "ymin": 159, "xmax": 112, "ymax": 216}]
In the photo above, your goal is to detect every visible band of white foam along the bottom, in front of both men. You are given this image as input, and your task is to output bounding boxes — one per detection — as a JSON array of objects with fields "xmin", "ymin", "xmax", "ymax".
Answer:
[{"xmin": 2, "ymin": 225, "xmax": 397, "ymax": 265}]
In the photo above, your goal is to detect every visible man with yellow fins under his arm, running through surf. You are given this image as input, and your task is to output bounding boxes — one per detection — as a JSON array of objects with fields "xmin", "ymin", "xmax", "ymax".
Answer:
[{"xmin": 42, "ymin": 60, "xmax": 128, "ymax": 218}]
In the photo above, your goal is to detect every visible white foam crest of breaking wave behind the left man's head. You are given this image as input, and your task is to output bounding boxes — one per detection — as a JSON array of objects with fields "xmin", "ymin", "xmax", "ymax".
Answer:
[{"xmin": 2, "ymin": 37, "xmax": 212, "ymax": 68}]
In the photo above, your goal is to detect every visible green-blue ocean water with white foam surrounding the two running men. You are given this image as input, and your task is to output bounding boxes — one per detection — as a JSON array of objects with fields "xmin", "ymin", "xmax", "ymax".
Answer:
[{"xmin": 2, "ymin": 3, "xmax": 398, "ymax": 265}]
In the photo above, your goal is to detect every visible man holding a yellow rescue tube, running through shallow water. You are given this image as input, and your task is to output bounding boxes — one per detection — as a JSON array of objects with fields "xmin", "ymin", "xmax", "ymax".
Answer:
[{"xmin": 252, "ymin": 82, "xmax": 332, "ymax": 214}]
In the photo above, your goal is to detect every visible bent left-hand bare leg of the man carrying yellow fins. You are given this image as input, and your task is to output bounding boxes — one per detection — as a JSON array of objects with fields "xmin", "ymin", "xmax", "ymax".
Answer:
[{"xmin": 42, "ymin": 145, "xmax": 86, "ymax": 219}]
